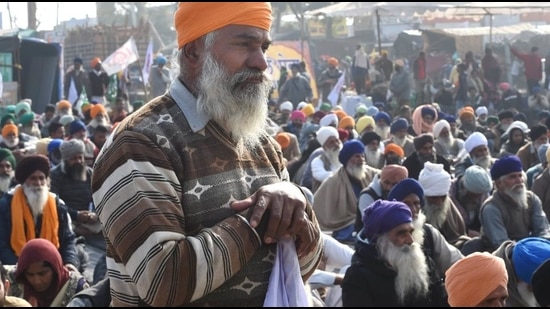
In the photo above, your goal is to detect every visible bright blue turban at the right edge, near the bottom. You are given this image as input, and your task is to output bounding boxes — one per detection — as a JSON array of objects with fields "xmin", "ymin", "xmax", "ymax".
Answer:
[{"xmin": 512, "ymin": 237, "xmax": 550, "ymax": 284}]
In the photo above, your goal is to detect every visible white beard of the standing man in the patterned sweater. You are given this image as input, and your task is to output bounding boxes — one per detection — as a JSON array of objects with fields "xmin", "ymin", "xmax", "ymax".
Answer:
[{"xmin": 197, "ymin": 50, "xmax": 272, "ymax": 149}]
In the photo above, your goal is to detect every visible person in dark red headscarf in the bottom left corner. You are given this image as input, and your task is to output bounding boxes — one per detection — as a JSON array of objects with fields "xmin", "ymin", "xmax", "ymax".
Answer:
[{"xmin": 10, "ymin": 238, "xmax": 89, "ymax": 307}]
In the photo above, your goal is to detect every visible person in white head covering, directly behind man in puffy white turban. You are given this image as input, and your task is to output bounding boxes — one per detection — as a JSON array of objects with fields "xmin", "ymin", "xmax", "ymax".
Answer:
[{"xmin": 433, "ymin": 119, "xmax": 464, "ymax": 165}]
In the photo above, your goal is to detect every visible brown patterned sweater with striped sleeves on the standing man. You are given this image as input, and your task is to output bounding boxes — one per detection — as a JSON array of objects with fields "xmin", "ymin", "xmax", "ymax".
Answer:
[{"xmin": 92, "ymin": 80, "xmax": 322, "ymax": 307}]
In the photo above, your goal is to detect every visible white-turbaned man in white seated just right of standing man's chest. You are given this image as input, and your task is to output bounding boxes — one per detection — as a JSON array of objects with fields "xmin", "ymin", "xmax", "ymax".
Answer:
[{"xmin": 310, "ymin": 126, "xmax": 342, "ymax": 193}]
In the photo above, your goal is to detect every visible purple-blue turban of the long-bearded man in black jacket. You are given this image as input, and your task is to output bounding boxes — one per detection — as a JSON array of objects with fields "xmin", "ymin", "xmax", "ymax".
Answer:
[{"xmin": 363, "ymin": 199, "xmax": 412, "ymax": 242}]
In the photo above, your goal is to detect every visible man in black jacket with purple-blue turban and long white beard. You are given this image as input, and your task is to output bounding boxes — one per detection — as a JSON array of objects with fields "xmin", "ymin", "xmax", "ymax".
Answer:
[{"xmin": 342, "ymin": 200, "xmax": 448, "ymax": 307}]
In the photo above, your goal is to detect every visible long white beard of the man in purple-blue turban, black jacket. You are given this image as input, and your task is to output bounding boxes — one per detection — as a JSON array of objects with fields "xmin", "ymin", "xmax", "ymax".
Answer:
[{"xmin": 376, "ymin": 235, "xmax": 430, "ymax": 304}]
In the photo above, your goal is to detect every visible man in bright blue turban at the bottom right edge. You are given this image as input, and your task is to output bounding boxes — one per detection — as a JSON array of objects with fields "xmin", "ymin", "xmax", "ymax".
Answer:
[{"xmin": 492, "ymin": 236, "xmax": 550, "ymax": 307}]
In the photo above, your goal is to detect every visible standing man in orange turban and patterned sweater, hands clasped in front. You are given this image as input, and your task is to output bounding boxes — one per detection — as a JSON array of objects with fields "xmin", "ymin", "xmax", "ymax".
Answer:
[{"xmin": 92, "ymin": 2, "xmax": 323, "ymax": 307}]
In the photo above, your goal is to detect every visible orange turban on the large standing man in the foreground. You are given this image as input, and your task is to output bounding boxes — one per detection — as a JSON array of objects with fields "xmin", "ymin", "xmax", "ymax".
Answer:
[{"xmin": 174, "ymin": 2, "xmax": 272, "ymax": 48}]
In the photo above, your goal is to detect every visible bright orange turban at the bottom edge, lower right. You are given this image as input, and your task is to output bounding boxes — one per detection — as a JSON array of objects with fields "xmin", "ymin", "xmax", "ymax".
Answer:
[{"xmin": 445, "ymin": 252, "xmax": 508, "ymax": 307}]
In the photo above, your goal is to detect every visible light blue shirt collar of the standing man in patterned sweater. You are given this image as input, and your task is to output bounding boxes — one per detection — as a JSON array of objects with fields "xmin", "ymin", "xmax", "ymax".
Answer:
[{"xmin": 170, "ymin": 78, "xmax": 210, "ymax": 133}]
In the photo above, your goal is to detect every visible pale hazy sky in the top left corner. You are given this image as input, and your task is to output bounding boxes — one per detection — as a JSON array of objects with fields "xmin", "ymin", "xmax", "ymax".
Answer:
[{"xmin": 0, "ymin": 2, "xmax": 96, "ymax": 31}]
